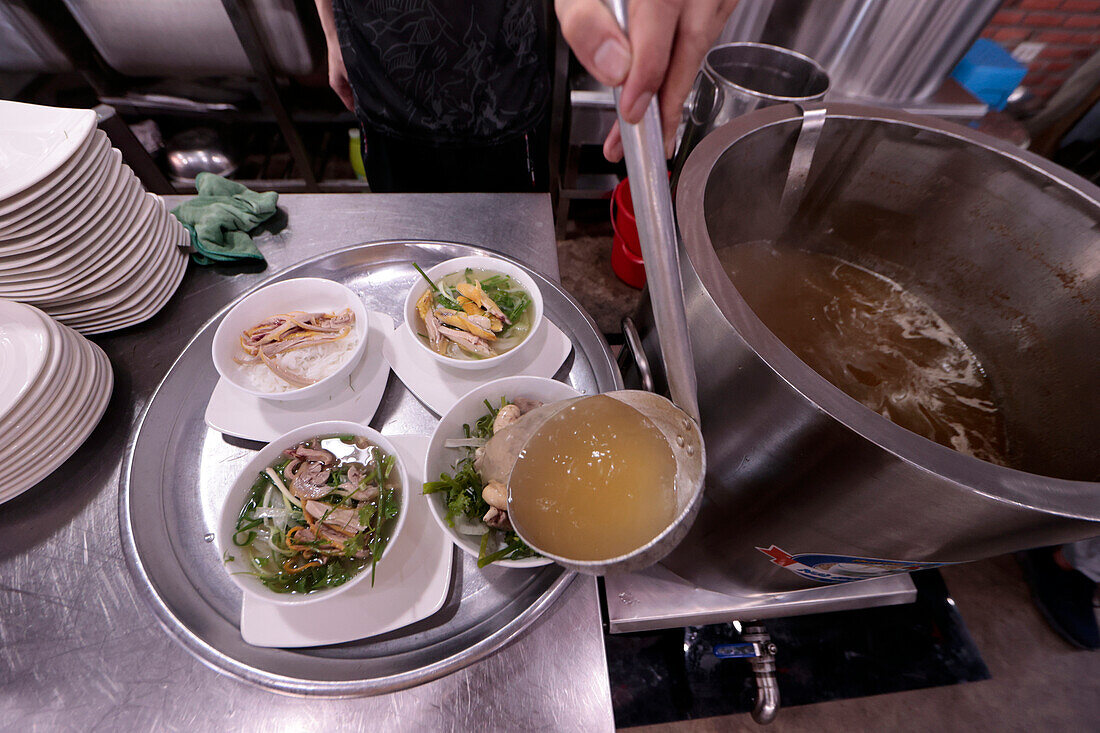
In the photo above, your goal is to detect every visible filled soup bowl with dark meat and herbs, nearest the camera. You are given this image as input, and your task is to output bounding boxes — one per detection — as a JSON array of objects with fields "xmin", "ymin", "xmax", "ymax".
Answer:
[{"xmin": 216, "ymin": 420, "xmax": 410, "ymax": 605}]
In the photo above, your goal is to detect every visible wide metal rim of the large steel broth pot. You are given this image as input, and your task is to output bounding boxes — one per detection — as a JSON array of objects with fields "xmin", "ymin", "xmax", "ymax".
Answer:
[{"xmin": 677, "ymin": 102, "xmax": 1100, "ymax": 522}]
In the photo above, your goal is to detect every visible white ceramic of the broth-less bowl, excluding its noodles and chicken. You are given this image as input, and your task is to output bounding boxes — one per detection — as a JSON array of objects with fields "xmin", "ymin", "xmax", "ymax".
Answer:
[{"xmin": 210, "ymin": 277, "xmax": 367, "ymax": 401}]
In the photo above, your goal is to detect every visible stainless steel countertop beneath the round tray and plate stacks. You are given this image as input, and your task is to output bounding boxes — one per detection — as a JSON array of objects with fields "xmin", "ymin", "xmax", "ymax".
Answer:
[{"xmin": 0, "ymin": 194, "xmax": 614, "ymax": 731}]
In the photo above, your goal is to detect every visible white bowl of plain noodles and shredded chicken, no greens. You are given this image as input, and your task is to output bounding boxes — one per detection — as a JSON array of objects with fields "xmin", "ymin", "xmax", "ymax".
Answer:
[{"xmin": 211, "ymin": 277, "xmax": 367, "ymax": 401}]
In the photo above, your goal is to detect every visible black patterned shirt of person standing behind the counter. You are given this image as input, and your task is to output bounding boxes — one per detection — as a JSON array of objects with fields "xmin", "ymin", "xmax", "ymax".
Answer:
[{"xmin": 332, "ymin": 0, "xmax": 550, "ymax": 145}]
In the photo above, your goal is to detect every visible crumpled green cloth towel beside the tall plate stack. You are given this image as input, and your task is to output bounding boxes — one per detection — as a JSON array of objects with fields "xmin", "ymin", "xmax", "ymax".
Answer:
[{"xmin": 172, "ymin": 172, "xmax": 278, "ymax": 265}]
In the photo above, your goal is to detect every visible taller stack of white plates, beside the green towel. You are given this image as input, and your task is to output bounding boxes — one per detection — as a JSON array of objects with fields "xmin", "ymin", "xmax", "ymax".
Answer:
[{"xmin": 0, "ymin": 101, "xmax": 189, "ymax": 333}]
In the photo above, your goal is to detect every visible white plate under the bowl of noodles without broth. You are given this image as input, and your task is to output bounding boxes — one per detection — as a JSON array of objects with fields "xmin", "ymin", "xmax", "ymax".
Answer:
[{"xmin": 206, "ymin": 310, "xmax": 394, "ymax": 442}]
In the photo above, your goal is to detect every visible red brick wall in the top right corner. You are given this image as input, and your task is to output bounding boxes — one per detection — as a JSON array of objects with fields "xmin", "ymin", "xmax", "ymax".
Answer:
[{"xmin": 981, "ymin": 0, "xmax": 1100, "ymax": 99}]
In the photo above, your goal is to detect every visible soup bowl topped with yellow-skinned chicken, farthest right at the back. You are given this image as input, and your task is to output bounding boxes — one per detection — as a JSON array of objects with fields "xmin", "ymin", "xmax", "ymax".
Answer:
[{"xmin": 404, "ymin": 255, "xmax": 542, "ymax": 370}]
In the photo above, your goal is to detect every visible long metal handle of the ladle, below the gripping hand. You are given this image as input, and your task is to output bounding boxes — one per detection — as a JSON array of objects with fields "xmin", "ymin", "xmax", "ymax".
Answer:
[{"xmin": 607, "ymin": 0, "xmax": 699, "ymax": 423}]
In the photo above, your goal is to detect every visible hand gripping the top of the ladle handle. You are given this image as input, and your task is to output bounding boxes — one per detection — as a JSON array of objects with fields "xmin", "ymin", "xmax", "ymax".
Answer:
[{"xmin": 554, "ymin": 0, "xmax": 737, "ymax": 163}]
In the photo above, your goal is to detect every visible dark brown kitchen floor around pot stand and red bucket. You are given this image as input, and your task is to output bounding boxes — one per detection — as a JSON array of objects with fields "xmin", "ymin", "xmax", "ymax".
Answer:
[{"xmin": 558, "ymin": 222, "xmax": 1100, "ymax": 733}]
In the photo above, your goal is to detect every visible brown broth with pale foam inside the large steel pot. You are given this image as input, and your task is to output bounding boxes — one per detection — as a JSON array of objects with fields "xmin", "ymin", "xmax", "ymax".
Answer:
[{"xmin": 718, "ymin": 242, "xmax": 1009, "ymax": 466}]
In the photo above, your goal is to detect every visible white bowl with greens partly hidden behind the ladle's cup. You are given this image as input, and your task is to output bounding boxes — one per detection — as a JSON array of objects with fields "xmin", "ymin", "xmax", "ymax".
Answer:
[{"xmin": 424, "ymin": 376, "xmax": 581, "ymax": 568}]
